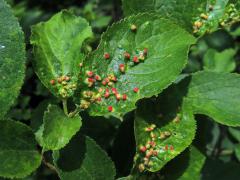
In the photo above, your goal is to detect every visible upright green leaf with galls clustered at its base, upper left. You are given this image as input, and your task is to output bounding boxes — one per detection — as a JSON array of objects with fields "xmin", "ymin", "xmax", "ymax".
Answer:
[{"xmin": 31, "ymin": 11, "xmax": 92, "ymax": 98}]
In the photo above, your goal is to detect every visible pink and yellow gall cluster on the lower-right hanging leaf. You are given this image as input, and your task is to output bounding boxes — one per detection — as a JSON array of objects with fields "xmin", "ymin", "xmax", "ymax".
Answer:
[{"xmin": 138, "ymin": 124, "xmax": 174, "ymax": 172}]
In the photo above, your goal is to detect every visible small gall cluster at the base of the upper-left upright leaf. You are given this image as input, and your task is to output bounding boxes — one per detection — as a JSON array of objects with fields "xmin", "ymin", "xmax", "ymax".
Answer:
[{"xmin": 50, "ymin": 75, "xmax": 77, "ymax": 98}]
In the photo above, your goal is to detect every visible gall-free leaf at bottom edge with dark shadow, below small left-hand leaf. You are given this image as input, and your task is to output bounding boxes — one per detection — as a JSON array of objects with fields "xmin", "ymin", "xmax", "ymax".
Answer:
[{"xmin": 53, "ymin": 134, "xmax": 115, "ymax": 180}]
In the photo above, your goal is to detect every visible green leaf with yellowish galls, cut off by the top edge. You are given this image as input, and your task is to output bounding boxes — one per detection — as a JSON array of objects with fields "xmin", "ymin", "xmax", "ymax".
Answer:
[{"xmin": 122, "ymin": 0, "xmax": 240, "ymax": 35}]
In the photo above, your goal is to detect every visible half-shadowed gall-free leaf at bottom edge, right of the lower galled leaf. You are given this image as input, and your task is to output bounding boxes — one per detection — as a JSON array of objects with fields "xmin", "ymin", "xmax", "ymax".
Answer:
[{"xmin": 163, "ymin": 146, "xmax": 206, "ymax": 180}]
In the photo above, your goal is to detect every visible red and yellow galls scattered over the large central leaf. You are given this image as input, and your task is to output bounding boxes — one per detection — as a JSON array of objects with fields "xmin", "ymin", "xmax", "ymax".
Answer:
[{"xmin": 80, "ymin": 30, "xmax": 148, "ymax": 112}]
